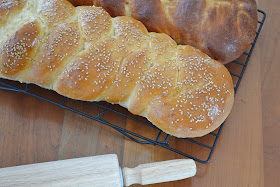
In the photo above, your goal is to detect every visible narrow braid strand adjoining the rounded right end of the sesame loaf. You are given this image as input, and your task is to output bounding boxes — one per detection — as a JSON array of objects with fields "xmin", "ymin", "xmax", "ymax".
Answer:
[{"xmin": 128, "ymin": 33, "xmax": 177, "ymax": 114}]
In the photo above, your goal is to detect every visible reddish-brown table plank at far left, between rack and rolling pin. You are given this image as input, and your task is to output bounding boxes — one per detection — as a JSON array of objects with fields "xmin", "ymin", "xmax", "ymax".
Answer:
[{"xmin": 0, "ymin": 87, "xmax": 65, "ymax": 167}]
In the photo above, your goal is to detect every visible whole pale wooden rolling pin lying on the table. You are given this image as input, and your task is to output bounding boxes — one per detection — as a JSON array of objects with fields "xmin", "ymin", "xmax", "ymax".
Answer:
[{"xmin": 0, "ymin": 154, "xmax": 196, "ymax": 187}]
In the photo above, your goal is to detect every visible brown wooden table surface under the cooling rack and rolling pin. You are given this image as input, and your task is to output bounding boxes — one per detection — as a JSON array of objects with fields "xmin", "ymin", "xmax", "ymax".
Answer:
[{"xmin": 0, "ymin": 0, "xmax": 280, "ymax": 187}]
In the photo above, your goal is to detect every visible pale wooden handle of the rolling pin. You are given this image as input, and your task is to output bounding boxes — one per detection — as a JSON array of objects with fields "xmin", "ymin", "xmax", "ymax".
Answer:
[{"xmin": 123, "ymin": 159, "xmax": 196, "ymax": 186}]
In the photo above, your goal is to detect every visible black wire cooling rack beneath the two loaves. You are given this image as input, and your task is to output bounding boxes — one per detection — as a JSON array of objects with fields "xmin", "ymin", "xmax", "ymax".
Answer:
[{"xmin": 0, "ymin": 10, "xmax": 266, "ymax": 164}]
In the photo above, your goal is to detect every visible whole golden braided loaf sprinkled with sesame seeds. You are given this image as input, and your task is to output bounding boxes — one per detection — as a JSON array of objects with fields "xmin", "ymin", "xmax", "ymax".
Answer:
[{"xmin": 0, "ymin": 0, "xmax": 234, "ymax": 137}]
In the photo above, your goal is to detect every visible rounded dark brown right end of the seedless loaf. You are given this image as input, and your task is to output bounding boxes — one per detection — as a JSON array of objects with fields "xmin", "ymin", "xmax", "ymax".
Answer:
[{"xmin": 200, "ymin": 0, "xmax": 258, "ymax": 64}]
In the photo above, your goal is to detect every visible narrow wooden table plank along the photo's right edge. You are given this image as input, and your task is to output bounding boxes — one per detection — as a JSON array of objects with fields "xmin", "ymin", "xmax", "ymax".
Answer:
[{"xmin": 258, "ymin": 0, "xmax": 280, "ymax": 187}]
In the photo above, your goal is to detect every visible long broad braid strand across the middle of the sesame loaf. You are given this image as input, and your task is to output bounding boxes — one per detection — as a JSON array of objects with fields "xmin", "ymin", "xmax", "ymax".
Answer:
[{"xmin": 56, "ymin": 13, "xmax": 150, "ymax": 102}]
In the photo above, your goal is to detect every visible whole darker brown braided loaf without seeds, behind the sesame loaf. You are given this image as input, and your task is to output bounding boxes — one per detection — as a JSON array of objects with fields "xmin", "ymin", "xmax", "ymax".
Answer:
[{"xmin": 69, "ymin": 0, "xmax": 257, "ymax": 64}]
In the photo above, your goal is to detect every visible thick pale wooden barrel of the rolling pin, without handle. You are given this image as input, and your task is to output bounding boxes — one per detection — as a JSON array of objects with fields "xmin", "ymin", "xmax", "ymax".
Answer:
[{"xmin": 0, "ymin": 154, "xmax": 122, "ymax": 187}]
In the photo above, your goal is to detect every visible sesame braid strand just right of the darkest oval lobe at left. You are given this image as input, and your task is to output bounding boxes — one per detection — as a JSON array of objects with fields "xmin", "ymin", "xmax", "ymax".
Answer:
[{"xmin": 22, "ymin": 23, "xmax": 82, "ymax": 88}]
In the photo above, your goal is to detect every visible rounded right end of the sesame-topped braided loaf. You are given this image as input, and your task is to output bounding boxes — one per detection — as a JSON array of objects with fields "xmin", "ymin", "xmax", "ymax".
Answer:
[{"xmin": 148, "ymin": 46, "xmax": 233, "ymax": 137}]
